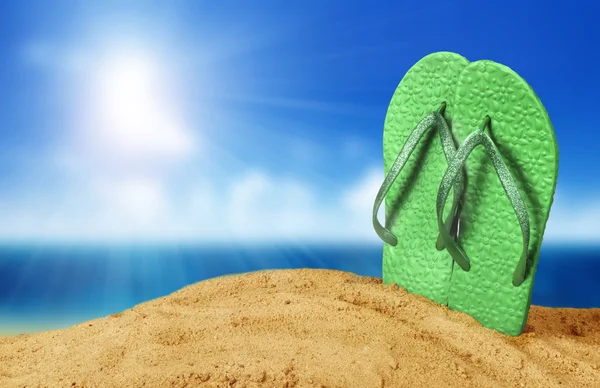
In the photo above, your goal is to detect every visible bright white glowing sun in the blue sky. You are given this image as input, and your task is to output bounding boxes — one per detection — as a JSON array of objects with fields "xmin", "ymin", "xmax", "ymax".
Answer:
[{"xmin": 90, "ymin": 49, "xmax": 191, "ymax": 161}]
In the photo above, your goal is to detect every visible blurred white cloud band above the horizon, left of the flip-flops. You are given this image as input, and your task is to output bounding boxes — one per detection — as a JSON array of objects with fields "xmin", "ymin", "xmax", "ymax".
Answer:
[{"xmin": 0, "ymin": 165, "xmax": 380, "ymax": 242}]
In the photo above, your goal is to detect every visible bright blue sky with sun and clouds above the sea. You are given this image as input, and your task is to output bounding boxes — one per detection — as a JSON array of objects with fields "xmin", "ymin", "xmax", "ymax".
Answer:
[{"xmin": 0, "ymin": 0, "xmax": 600, "ymax": 243}]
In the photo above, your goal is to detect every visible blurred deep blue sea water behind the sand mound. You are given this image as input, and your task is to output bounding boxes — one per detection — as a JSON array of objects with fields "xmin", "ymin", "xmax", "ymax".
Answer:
[{"xmin": 0, "ymin": 245, "xmax": 600, "ymax": 334}]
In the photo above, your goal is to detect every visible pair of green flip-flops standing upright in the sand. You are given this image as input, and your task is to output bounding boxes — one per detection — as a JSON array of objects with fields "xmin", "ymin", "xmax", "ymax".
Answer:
[{"xmin": 373, "ymin": 52, "xmax": 558, "ymax": 335}]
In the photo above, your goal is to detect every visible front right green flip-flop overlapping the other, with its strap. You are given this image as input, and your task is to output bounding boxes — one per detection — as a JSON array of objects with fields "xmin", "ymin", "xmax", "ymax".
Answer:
[{"xmin": 436, "ymin": 61, "xmax": 558, "ymax": 335}]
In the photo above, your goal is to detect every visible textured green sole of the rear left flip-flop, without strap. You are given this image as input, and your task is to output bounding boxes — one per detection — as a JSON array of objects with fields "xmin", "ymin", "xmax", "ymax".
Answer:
[{"xmin": 382, "ymin": 52, "xmax": 469, "ymax": 304}]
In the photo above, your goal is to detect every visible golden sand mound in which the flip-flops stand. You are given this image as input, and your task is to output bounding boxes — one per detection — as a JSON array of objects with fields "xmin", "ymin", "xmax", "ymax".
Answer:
[{"xmin": 0, "ymin": 269, "xmax": 600, "ymax": 388}]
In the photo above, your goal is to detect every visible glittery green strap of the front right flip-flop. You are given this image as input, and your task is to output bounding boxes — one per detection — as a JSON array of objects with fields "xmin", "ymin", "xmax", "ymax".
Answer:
[{"xmin": 436, "ymin": 116, "xmax": 530, "ymax": 286}]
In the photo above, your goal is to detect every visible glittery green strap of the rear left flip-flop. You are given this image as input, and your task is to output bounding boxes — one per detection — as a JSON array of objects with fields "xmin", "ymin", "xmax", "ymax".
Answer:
[{"xmin": 373, "ymin": 103, "xmax": 464, "ymax": 246}]
